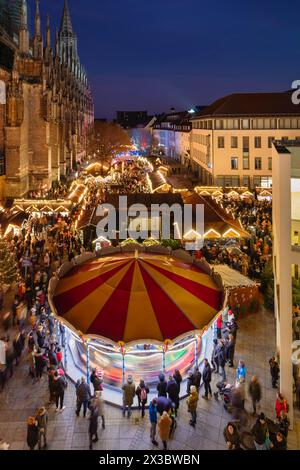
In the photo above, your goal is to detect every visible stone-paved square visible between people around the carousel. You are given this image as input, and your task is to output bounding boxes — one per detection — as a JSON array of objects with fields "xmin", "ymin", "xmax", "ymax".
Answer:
[{"xmin": 0, "ymin": 311, "xmax": 300, "ymax": 450}]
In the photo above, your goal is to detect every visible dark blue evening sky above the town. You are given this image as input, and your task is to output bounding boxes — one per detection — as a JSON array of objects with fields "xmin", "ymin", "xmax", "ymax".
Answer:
[{"xmin": 29, "ymin": 0, "xmax": 300, "ymax": 117}]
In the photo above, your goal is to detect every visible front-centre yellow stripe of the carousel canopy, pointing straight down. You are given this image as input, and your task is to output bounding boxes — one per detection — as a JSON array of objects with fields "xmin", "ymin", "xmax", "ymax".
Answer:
[{"xmin": 124, "ymin": 263, "xmax": 163, "ymax": 342}]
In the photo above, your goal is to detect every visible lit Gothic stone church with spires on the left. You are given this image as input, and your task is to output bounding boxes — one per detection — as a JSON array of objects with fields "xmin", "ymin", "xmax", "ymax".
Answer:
[{"xmin": 0, "ymin": 0, "xmax": 94, "ymax": 197}]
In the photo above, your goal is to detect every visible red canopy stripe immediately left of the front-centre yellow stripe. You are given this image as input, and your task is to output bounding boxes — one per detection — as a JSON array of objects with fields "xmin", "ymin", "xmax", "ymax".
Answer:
[{"xmin": 88, "ymin": 263, "xmax": 135, "ymax": 342}]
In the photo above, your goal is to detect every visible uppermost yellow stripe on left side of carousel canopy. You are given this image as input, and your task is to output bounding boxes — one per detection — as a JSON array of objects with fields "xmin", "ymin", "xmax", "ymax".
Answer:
[{"xmin": 55, "ymin": 259, "xmax": 129, "ymax": 295}]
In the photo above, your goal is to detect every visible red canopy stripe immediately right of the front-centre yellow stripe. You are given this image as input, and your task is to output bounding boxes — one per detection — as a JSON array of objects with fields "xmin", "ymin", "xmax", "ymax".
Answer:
[{"xmin": 140, "ymin": 264, "xmax": 195, "ymax": 339}]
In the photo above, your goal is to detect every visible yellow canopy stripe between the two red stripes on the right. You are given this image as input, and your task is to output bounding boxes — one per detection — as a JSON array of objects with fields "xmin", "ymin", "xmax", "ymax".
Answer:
[{"xmin": 142, "ymin": 262, "xmax": 216, "ymax": 329}]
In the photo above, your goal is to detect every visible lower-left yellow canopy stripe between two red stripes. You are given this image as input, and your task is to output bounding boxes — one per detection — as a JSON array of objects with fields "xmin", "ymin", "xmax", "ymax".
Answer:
[{"xmin": 64, "ymin": 260, "xmax": 133, "ymax": 333}]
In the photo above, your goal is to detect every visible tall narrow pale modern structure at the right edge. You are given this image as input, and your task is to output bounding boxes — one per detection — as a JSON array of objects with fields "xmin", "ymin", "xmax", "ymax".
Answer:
[{"xmin": 272, "ymin": 140, "xmax": 300, "ymax": 426}]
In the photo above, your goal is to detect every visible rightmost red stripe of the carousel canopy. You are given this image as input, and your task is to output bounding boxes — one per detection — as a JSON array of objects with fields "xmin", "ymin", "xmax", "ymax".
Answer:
[{"xmin": 143, "ymin": 259, "xmax": 221, "ymax": 310}]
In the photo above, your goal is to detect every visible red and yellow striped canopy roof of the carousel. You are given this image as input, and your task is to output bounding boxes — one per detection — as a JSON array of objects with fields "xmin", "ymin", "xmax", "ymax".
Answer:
[{"xmin": 54, "ymin": 254, "xmax": 221, "ymax": 343}]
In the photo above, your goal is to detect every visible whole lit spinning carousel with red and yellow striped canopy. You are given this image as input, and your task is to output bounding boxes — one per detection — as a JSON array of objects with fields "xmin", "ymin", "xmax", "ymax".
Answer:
[{"xmin": 49, "ymin": 252, "xmax": 224, "ymax": 404}]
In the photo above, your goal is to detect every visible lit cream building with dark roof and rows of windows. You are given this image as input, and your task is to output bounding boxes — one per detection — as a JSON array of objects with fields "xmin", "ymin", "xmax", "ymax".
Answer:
[{"xmin": 190, "ymin": 92, "xmax": 300, "ymax": 188}]
